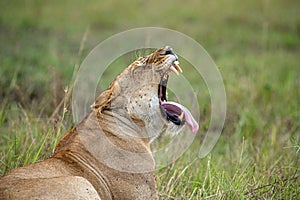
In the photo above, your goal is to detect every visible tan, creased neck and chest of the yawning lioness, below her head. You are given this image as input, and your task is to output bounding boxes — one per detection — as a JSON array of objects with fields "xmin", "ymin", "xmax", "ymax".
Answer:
[{"xmin": 53, "ymin": 111, "xmax": 156, "ymax": 199}]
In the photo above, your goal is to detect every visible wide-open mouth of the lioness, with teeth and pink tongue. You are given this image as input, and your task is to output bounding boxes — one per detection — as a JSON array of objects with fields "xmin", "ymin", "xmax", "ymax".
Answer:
[{"xmin": 158, "ymin": 60, "xmax": 199, "ymax": 133}]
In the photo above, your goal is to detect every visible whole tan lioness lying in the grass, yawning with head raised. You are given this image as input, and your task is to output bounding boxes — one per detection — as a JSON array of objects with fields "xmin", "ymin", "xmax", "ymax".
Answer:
[{"xmin": 0, "ymin": 47, "xmax": 198, "ymax": 200}]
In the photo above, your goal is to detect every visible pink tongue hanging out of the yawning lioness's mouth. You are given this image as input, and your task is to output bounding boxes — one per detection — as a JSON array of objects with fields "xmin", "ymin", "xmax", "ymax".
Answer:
[{"xmin": 161, "ymin": 101, "xmax": 199, "ymax": 133}]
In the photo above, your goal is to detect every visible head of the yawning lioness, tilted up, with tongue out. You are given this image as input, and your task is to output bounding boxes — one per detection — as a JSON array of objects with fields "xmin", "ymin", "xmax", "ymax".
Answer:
[{"xmin": 93, "ymin": 46, "xmax": 198, "ymax": 140}]
